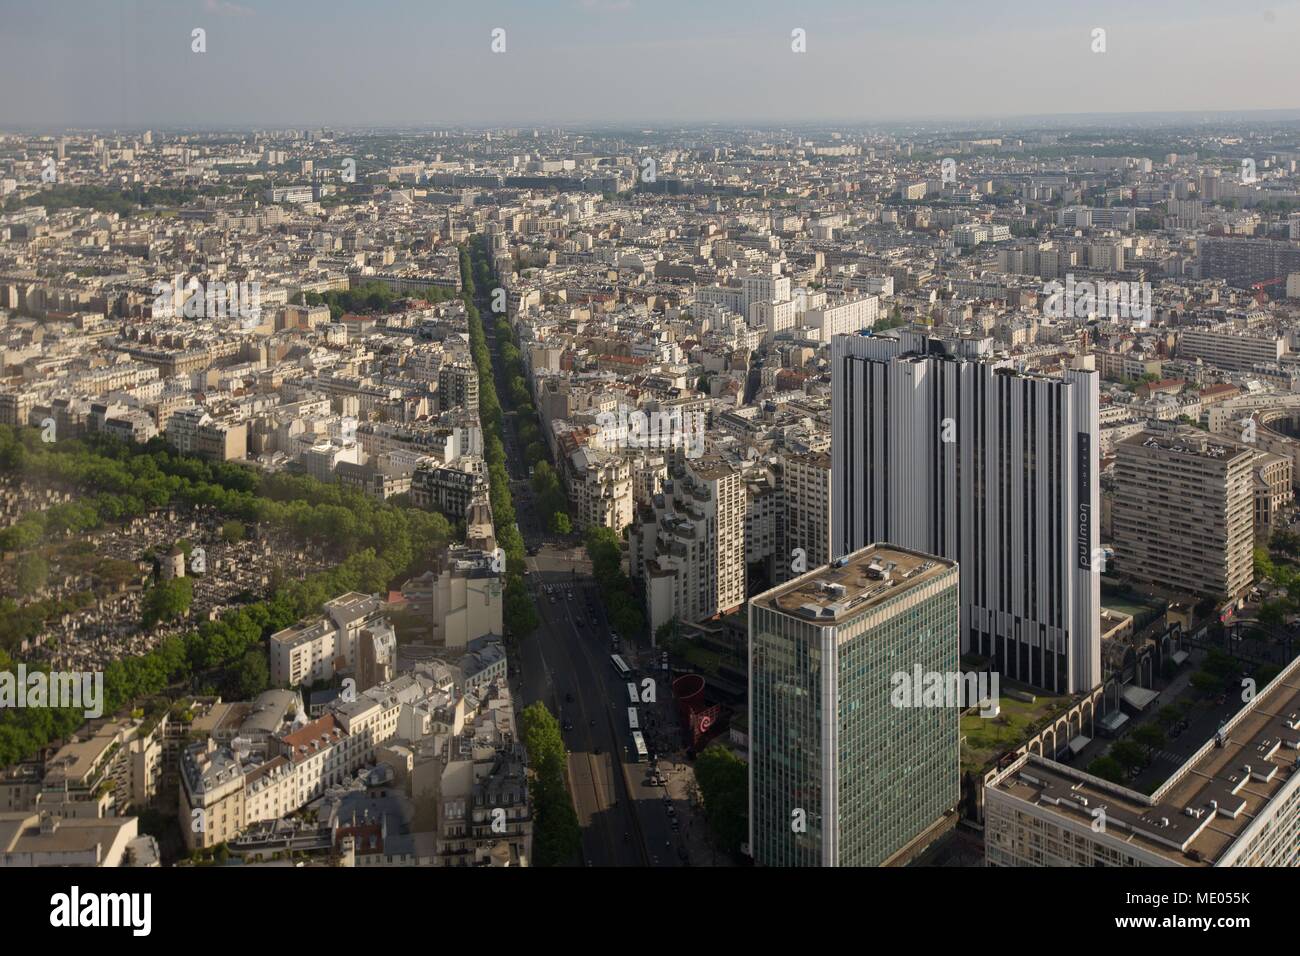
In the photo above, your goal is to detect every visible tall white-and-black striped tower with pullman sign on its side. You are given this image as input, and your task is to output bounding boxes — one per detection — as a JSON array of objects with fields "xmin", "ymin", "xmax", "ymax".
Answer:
[{"xmin": 831, "ymin": 332, "xmax": 1101, "ymax": 693}]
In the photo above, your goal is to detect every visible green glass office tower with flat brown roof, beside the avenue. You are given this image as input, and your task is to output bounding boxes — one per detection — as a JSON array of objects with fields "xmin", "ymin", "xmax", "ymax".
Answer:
[{"xmin": 749, "ymin": 545, "xmax": 961, "ymax": 866}]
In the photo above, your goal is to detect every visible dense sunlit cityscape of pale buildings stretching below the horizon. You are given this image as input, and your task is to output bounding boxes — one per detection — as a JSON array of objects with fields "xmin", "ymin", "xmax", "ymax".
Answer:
[{"xmin": 0, "ymin": 4, "xmax": 1300, "ymax": 925}]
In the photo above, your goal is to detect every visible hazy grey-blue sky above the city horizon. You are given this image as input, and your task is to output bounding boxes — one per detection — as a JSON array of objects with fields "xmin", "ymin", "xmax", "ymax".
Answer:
[{"xmin": 0, "ymin": 0, "xmax": 1300, "ymax": 127}]
